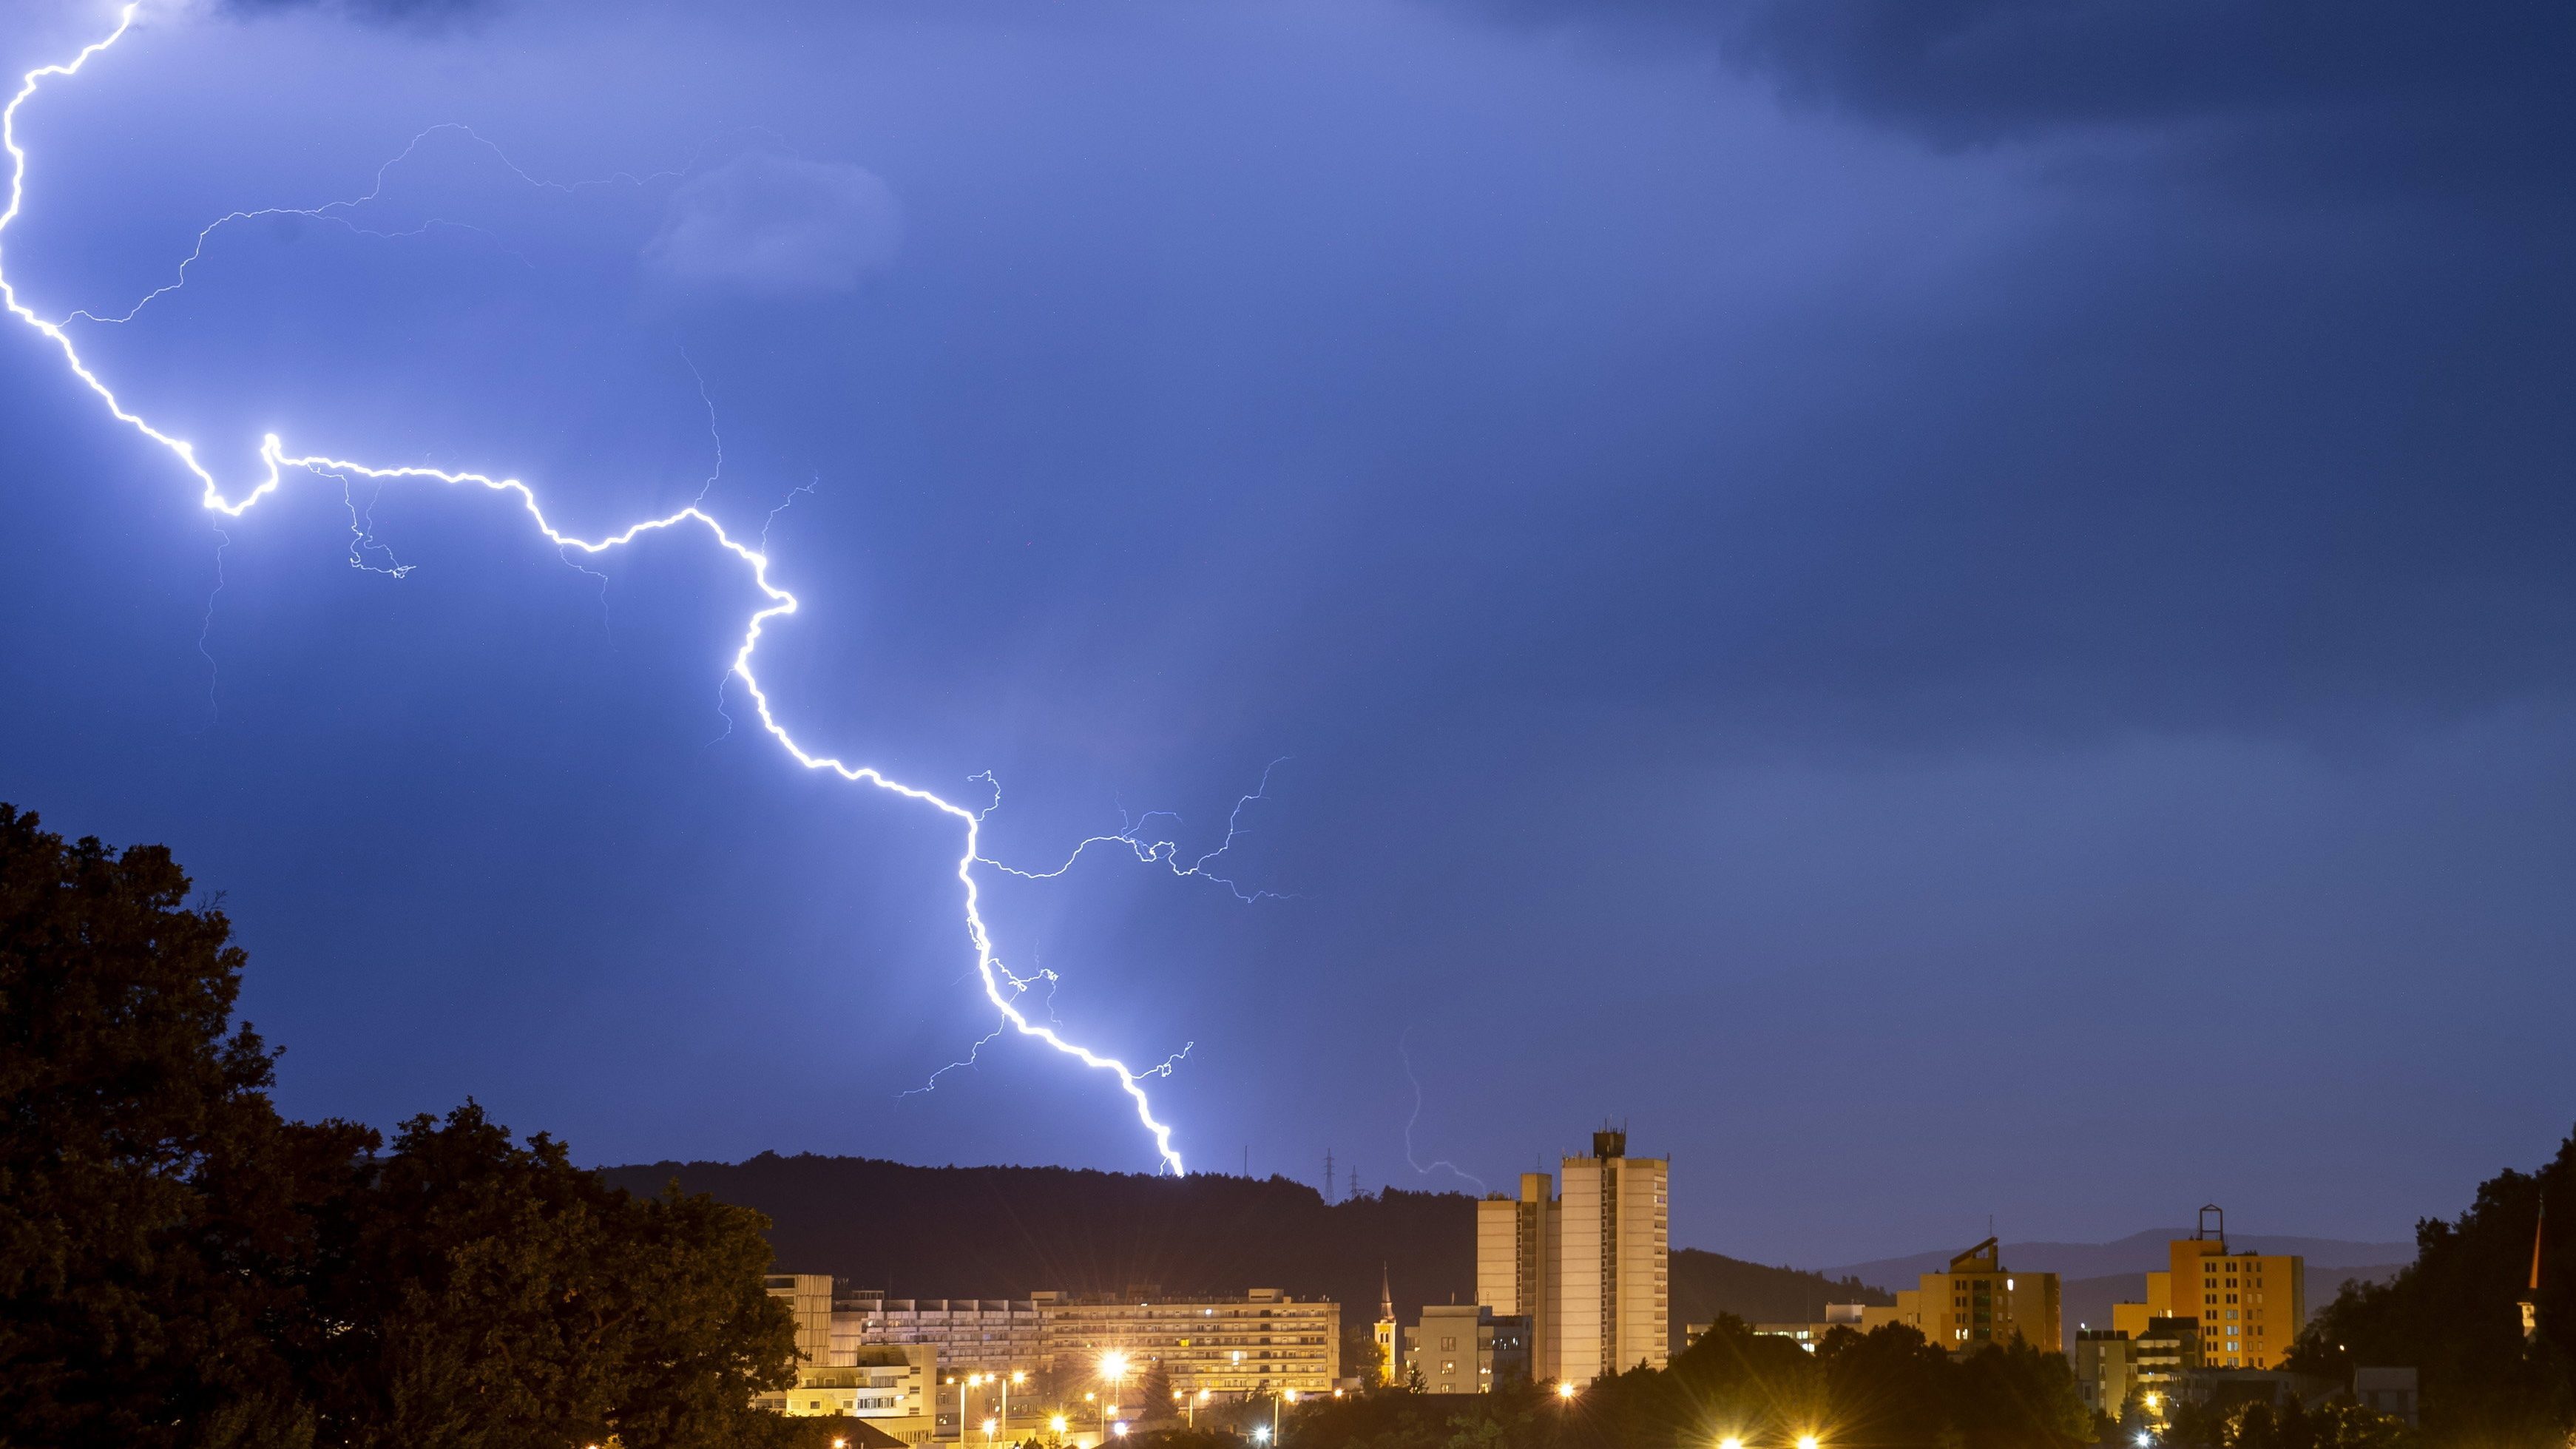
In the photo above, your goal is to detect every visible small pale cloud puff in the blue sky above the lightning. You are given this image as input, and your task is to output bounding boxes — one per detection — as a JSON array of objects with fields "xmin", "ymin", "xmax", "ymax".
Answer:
[{"xmin": 644, "ymin": 152, "xmax": 902, "ymax": 297}]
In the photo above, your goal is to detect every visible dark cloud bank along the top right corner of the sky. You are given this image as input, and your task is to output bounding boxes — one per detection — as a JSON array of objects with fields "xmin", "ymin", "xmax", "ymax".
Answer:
[{"xmin": 1494, "ymin": 0, "xmax": 2576, "ymax": 186}]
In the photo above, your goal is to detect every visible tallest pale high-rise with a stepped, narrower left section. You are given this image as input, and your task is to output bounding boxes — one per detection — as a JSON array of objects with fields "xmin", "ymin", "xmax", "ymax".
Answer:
[{"xmin": 1476, "ymin": 1129, "xmax": 1671, "ymax": 1385}]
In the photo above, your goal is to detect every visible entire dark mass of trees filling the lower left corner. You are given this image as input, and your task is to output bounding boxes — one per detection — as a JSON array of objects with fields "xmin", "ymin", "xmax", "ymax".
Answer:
[{"xmin": 0, "ymin": 805, "xmax": 794, "ymax": 1449}]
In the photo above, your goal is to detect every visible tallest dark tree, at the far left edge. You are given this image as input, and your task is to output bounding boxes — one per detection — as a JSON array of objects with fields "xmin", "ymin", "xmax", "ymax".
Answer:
[{"xmin": 0, "ymin": 805, "xmax": 337, "ymax": 1447}]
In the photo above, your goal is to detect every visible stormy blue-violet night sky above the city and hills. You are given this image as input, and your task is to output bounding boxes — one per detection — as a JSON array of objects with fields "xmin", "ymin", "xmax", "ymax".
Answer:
[{"xmin": 0, "ymin": 0, "xmax": 2576, "ymax": 1263}]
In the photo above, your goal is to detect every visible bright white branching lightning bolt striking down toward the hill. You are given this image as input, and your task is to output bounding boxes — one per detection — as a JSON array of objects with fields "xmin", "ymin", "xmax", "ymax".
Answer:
[{"xmin": 0, "ymin": 2, "xmax": 1270, "ymax": 1176}]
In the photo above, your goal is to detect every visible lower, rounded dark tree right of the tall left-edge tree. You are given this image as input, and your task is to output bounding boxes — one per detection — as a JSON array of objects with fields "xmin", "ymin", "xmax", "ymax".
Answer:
[{"xmin": 296, "ymin": 1104, "xmax": 796, "ymax": 1449}]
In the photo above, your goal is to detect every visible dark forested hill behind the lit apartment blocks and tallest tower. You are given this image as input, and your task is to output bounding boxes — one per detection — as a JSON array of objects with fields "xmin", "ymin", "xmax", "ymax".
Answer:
[{"xmin": 601, "ymin": 1152, "xmax": 1891, "ymax": 1346}]
